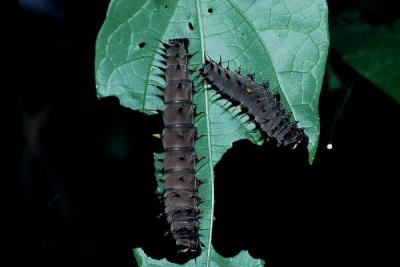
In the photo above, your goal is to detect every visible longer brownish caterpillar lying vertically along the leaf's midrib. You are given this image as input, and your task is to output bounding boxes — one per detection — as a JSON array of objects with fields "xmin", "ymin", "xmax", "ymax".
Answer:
[{"xmin": 160, "ymin": 39, "xmax": 200, "ymax": 253}]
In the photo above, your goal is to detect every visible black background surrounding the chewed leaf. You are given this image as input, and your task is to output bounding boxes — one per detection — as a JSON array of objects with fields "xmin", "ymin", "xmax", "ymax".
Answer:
[{"xmin": 17, "ymin": 0, "xmax": 400, "ymax": 266}]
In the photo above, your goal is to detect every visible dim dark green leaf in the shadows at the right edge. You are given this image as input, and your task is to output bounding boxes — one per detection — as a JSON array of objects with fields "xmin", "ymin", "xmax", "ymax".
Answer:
[{"xmin": 332, "ymin": 20, "xmax": 400, "ymax": 103}]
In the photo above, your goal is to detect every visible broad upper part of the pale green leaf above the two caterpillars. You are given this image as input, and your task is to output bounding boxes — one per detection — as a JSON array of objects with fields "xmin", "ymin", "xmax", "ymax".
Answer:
[{"xmin": 95, "ymin": 0, "xmax": 329, "ymax": 161}]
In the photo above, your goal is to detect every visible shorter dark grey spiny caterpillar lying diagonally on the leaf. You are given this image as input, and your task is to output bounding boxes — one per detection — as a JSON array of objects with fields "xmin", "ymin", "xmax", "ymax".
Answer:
[{"xmin": 199, "ymin": 59, "xmax": 306, "ymax": 148}]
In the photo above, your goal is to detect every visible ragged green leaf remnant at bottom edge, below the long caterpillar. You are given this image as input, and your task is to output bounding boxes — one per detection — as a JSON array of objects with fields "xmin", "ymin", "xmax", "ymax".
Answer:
[{"xmin": 133, "ymin": 249, "xmax": 264, "ymax": 267}]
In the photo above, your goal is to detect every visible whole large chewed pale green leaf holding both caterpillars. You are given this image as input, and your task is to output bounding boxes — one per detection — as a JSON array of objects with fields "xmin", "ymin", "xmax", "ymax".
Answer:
[{"xmin": 95, "ymin": 0, "xmax": 329, "ymax": 266}]
